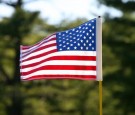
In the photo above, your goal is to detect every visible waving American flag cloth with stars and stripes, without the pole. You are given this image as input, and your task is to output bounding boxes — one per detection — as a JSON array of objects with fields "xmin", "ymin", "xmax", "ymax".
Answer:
[{"xmin": 20, "ymin": 19, "xmax": 97, "ymax": 80}]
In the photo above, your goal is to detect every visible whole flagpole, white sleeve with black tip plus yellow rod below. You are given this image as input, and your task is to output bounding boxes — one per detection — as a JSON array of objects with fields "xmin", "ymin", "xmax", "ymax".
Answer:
[{"xmin": 96, "ymin": 16, "xmax": 103, "ymax": 115}]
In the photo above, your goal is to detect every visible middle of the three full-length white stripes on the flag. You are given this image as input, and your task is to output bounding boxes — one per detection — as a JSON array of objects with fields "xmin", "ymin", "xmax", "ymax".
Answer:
[{"xmin": 21, "ymin": 60, "xmax": 96, "ymax": 72}]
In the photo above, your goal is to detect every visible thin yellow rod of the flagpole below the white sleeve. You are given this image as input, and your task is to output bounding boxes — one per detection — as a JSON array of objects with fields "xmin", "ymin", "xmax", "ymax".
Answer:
[{"xmin": 99, "ymin": 81, "xmax": 103, "ymax": 115}]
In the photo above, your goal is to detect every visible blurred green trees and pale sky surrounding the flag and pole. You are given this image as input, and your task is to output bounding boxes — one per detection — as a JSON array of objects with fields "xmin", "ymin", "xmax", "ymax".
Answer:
[{"xmin": 0, "ymin": 0, "xmax": 135, "ymax": 115}]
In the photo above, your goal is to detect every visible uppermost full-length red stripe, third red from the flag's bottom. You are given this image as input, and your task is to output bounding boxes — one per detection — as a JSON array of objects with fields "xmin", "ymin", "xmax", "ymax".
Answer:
[{"xmin": 21, "ymin": 54, "xmax": 96, "ymax": 68}]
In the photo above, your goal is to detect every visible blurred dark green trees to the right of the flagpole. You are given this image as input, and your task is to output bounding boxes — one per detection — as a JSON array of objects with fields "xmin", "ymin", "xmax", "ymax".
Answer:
[{"xmin": 99, "ymin": 0, "xmax": 135, "ymax": 115}]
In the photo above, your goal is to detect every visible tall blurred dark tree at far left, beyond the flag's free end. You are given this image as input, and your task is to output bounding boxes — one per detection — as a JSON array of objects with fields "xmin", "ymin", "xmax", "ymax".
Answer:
[{"xmin": 0, "ymin": 0, "xmax": 38, "ymax": 115}]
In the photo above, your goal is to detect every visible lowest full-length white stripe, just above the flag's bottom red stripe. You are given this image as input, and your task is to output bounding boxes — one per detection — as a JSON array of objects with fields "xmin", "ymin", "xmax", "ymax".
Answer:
[{"xmin": 21, "ymin": 70, "xmax": 96, "ymax": 79}]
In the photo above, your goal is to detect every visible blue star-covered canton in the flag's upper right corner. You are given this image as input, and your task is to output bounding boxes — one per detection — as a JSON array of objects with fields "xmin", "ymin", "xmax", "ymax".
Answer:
[{"xmin": 56, "ymin": 19, "xmax": 96, "ymax": 51}]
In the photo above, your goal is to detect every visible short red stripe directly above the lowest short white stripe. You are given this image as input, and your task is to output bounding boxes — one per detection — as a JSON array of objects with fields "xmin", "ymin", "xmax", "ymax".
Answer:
[{"xmin": 21, "ymin": 43, "xmax": 56, "ymax": 58}]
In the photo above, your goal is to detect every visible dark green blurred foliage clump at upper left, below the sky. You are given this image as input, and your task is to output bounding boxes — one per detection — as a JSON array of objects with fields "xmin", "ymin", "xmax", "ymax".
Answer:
[{"xmin": 0, "ymin": 9, "xmax": 38, "ymax": 38}]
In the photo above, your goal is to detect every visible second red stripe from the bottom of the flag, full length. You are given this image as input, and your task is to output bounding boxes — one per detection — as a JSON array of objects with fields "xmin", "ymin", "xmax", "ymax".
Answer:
[{"xmin": 21, "ymin": 65, "xmax": 96, "ymax": 76}]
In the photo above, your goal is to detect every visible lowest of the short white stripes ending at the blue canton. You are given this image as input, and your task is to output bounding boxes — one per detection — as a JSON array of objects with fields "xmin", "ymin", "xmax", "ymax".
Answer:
[{"xmin": 22, "ymin": 46, "xmax": 56, "ymax": 60}]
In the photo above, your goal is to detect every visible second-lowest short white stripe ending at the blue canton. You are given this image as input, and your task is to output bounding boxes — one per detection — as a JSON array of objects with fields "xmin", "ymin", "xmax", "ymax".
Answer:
[{"xmin": 22, "ymin": 40, "xmax": 56, "ymax": 54}]
